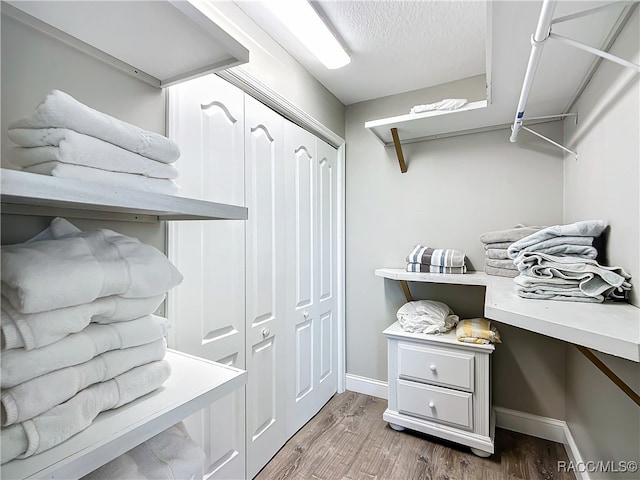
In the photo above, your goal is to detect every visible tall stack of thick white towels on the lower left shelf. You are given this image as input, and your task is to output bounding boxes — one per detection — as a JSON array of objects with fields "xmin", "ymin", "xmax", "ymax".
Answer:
[{"xmin": 0, "ymin": 218, "xmax": 182, "ymax": 463}]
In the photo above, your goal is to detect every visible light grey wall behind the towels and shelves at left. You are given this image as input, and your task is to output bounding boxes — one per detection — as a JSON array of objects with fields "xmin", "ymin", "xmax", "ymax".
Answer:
[{"xmin": 1, "ymin": 15, "xmax": 165, "ymax": 250}]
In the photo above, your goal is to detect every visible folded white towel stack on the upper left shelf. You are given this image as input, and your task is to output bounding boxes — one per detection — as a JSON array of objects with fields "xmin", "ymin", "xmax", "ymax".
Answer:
[{"xmin": 7, "ymin": 90, "xmax": 180, "ymax": 195}]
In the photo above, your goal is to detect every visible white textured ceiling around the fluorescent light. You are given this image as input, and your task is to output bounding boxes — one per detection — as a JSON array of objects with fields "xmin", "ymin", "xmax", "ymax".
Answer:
[{"xmin": 238, "ymin": 0, "xmax": 487, "ymax": 105}]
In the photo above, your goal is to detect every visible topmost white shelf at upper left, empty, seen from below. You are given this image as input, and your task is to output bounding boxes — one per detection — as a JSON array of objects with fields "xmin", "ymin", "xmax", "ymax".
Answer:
[{"xmin": 2, "ymin": 0, "xmax": 249, "ymax": 87}]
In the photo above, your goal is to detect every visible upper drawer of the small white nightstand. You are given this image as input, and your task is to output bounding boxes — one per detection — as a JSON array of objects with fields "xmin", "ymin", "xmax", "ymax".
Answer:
[{"xmin": 398, "ymin": 343, "xmax": 474, "ymax": 392}]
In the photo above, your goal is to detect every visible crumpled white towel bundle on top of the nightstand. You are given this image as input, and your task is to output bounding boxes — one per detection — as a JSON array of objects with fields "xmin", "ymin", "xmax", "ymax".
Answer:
[{"xmin": 396, "ymin": 300, "xmax": 459, "ymax": 333}]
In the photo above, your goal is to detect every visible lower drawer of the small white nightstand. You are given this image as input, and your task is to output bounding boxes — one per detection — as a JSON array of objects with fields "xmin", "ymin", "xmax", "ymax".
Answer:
[{"xmin": 397, "ymin": 380, "xmax": 473, "ymax": 430}]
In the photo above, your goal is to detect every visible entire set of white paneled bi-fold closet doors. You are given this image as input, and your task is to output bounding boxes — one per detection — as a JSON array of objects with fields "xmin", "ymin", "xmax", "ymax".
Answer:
[{"xmin": 169, "ymin": 76, "xmax": 337, "ymax": 479}]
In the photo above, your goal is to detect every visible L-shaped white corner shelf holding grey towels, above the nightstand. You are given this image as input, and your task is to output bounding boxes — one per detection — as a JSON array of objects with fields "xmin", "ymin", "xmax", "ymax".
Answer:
[{"xmin": 375, "ymin": 268, "xmax": 640, "ymax": 362}]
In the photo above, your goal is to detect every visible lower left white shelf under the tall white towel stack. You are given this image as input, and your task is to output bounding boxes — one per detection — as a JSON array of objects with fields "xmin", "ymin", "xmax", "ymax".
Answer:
[{"xmin": 2, "ymin": 350, "xmax": 247, "ymax": 480}]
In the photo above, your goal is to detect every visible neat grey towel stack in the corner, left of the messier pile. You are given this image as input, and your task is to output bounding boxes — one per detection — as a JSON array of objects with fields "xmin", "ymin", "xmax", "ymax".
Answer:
[{"xmin": 480, "ymin": 225, "xmax": 544, "ymax": 278}]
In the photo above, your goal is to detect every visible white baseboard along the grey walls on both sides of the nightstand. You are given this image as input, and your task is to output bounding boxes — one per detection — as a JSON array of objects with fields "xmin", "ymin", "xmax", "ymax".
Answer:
[{"xmin": 346, "ymin": 373, "xmax": 590, "ymax": 480}]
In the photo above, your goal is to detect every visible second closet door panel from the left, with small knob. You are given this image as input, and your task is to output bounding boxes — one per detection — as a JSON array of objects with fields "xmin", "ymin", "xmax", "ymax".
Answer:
[{"xmin": 245, "ymin": 96, "xmax": 288, "ymax": 478}]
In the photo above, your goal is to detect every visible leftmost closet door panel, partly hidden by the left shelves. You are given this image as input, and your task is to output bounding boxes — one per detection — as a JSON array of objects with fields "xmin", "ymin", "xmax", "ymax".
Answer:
[{"xmin": 169, "ymin": 76, "xmax": 245, "ymax": 479}]
